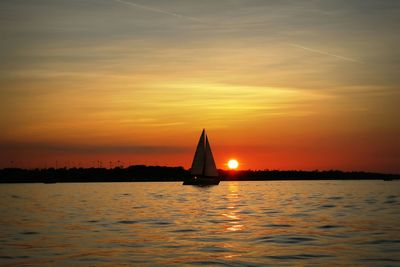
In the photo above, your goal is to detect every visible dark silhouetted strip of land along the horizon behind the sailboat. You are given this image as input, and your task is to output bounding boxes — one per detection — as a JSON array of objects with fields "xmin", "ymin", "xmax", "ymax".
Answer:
[{"xmin": 0, "ymin": 165, "xmax": 400, "ymax": 183}]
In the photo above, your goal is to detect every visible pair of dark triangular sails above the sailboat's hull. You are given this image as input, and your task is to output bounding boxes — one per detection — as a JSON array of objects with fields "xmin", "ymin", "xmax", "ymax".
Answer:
[{"xmin": 190, "ymin": 130, "xmax": 218, "ymax": 177}]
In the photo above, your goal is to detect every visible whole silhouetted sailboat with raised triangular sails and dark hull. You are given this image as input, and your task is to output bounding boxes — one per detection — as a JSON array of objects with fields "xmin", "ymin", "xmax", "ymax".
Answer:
[{"xmin": 183, "ymin": 129, "xmax": 219, "ymax": 186}]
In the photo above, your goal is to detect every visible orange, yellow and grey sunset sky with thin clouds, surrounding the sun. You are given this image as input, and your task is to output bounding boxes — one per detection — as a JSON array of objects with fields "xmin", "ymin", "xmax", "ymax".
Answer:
[{"xmin": 0, "ymin": 0, "xmax": 400, "ymax": 173}]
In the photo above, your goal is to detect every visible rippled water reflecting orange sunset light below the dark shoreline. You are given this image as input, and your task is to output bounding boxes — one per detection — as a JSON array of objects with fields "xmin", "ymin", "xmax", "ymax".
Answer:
[{"xmin": 0, "ymin": 181, "xmax": 400, "ymax": 266}]
